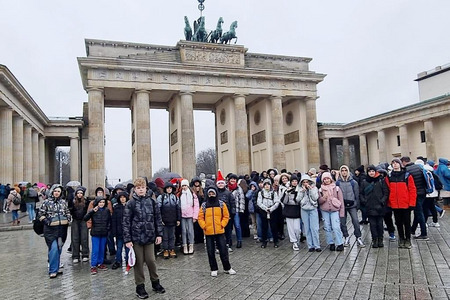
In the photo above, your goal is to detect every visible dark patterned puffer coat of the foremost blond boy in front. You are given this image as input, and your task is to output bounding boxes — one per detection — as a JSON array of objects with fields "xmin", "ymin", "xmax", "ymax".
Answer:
[{"xmin": 123, "ymin": 191, "xmax": 163, "ymax": 245}]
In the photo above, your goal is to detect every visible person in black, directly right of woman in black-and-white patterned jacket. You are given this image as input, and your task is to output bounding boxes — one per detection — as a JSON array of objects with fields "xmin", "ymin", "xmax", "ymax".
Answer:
[{"xmin": 67, "ymin": 186, "xmax": 89, "ymax": 263}]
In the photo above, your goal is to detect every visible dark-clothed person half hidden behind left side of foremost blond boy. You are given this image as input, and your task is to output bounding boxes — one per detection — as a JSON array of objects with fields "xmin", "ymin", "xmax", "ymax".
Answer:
[{"xmin": 111, "ymin": 191, "xmax": 130, "ymax": 270}]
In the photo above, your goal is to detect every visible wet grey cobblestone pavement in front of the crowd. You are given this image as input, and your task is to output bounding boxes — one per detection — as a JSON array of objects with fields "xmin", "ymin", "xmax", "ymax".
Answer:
[{"xmin": 0, "ymin": 214, "xmax": 450, "ymax": 299}]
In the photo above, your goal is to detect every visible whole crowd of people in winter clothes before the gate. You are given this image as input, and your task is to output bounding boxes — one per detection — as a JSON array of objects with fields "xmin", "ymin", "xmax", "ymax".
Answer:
[{"xmin": 0, "ymin": 157, "xmax": 450, "ymax": 298}]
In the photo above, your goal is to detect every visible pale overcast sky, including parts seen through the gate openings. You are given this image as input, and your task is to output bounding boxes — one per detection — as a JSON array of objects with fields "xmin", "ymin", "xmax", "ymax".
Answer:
[{"xmin": 0, "ymin": 0, "xmax": 450, "ymax": 180}]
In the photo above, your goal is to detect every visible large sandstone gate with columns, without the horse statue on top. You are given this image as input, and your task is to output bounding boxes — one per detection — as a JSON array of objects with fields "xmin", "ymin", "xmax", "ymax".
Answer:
[{"xmin": 78, "ymin": 39, "xmax": 325, "ymax": 191}]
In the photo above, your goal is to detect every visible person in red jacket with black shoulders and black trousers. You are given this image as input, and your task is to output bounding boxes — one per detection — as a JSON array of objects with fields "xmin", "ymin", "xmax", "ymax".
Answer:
[{"xmin": 386, "ymin": 158, "xmax": 416, "ymax": 249}]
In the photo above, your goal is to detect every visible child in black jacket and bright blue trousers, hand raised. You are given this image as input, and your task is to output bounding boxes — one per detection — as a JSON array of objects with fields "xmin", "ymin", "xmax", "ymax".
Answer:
[{"xmin": 84, "ymin": 196, "xmax": 111, "ymax": 275}]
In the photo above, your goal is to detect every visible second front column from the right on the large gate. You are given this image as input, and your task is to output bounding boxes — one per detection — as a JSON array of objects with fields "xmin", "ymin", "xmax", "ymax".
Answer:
[{"xmin": 270, "ymin": 96, "xmax": 286, "ymax": 170}]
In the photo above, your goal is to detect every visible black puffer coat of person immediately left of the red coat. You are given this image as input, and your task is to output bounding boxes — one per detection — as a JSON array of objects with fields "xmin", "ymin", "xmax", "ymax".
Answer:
[{"xmin": 359, "ymin": 176, "xmax": 389, "ymax": 216}]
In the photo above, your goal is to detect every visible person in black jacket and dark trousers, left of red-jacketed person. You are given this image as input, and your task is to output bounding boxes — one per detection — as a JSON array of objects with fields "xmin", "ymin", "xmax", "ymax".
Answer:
[{"xmin": 359, "ymin": 165, "xmax": 389, "ymax": 248}]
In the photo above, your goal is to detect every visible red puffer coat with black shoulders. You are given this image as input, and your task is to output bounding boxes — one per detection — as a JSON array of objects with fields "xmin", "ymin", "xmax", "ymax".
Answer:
[{"xmin": 386, "ymin": 170, "xmax": 416, "ymax": 209}]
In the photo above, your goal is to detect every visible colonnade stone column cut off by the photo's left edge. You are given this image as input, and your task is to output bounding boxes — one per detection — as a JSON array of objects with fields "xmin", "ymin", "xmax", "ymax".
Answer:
[{"xmin": 0, "ymin": 107, "xmax": 14, "ymax": 185}]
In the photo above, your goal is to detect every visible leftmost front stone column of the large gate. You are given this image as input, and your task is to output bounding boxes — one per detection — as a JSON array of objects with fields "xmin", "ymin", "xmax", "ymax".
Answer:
[{"xmin": 88, "ymin": 88, "xmax": 105, "ymax": 195}]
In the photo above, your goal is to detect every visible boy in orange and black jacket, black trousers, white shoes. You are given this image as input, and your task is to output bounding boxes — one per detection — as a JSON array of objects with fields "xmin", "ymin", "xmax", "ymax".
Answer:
[{"xmin": 198, "ymin": 186, "xmax": 236, "ymax": 277}]
